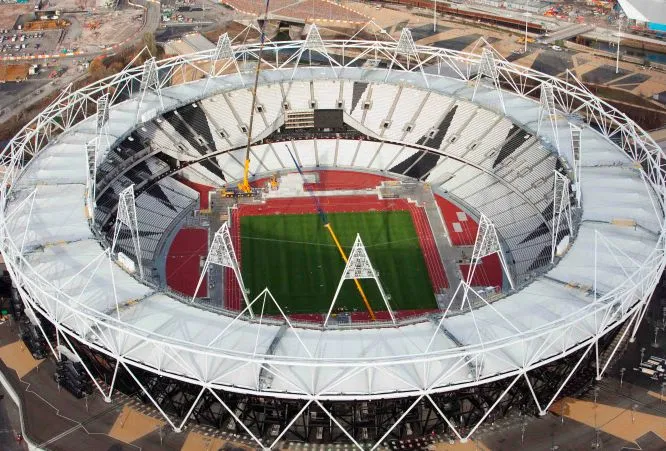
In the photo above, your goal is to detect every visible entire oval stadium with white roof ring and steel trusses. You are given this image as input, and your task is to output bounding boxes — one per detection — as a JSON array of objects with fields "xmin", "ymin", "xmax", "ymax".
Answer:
[{"xmin": 0, "ymin": 26, "xmax": 665, "ymax": 448}]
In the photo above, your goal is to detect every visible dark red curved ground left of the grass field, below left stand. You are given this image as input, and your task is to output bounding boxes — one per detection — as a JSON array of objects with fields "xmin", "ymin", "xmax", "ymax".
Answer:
[{"xmin": 166, "ymin": 228, "xmax": 208, "ymax": 296}]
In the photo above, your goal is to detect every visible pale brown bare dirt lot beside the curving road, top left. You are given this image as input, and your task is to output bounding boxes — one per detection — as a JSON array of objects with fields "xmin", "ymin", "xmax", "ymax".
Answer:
[{"xmin": 62, "ymin": 9, "xmax": 143, "ymax": 51}]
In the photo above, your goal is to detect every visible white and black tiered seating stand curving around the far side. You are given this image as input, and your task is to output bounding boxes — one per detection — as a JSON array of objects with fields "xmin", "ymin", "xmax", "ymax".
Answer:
[{"xmin": 98, "ymin": 79, "xmax": 561, "ymax": 288}]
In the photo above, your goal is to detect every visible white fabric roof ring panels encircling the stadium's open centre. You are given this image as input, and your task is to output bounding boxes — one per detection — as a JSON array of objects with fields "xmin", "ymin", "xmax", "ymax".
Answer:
[{"xmin": 3, "ymin": 61, "xmax": 659, "ymax": 396}]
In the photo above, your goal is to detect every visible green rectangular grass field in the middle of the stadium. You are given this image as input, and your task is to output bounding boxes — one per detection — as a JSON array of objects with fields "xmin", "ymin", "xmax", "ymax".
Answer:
[{"xmin": 240, "ymin": 211, "xmax": 437, "ymax": 314}]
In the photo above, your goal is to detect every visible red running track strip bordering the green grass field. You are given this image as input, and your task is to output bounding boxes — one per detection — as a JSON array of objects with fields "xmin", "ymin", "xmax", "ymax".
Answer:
[{"xmin": 225, "ymin": 195, "xmax": 448, "ymax": 314}]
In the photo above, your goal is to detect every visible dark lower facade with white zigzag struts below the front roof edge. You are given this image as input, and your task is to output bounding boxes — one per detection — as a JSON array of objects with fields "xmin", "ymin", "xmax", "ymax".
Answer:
[{"xmin": 31, "ymin": 314, "xmax": 612, "ymax": 448}]
